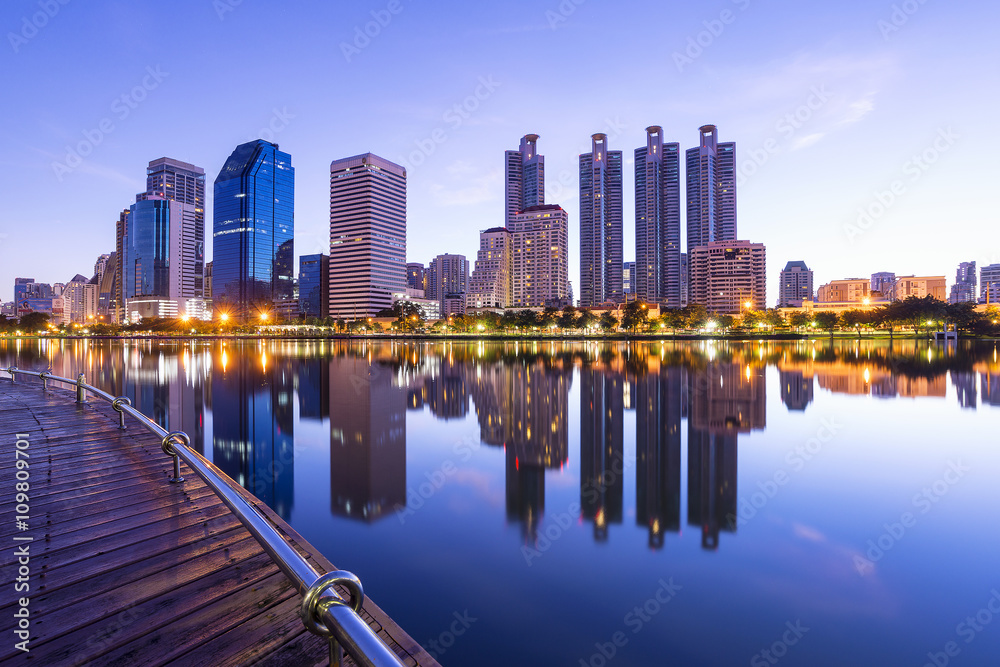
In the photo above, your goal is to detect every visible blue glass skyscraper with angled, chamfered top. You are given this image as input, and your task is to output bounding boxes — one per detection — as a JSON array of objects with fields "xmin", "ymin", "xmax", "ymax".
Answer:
[{"xmin": 212, "ymin": 139, "xmax": 295, "ymax": 320}]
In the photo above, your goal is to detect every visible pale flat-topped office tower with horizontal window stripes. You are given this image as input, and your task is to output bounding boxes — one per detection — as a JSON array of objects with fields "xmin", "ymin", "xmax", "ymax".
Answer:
[{"xmin": 330, "ymin": 153, "xmax": 406, "ymax": 318}]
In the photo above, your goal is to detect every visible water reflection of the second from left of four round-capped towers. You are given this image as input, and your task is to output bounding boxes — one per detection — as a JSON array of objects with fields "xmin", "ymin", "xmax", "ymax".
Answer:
[{"xmin": 580, "ymin": 368, "xmax": 625, "ymax": 542}]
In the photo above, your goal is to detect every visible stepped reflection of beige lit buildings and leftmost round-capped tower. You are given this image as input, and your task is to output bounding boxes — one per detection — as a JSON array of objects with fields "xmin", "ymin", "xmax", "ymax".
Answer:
[{"xmin": 466, "ymin": 362, "xmax": 572, "ymax": 541}]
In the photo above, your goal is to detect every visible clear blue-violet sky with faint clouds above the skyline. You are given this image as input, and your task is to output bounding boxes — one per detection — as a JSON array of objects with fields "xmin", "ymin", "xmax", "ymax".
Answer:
[{"xmin": 0, "ymin": 0, "xmax": 1000, "ymax": 304}]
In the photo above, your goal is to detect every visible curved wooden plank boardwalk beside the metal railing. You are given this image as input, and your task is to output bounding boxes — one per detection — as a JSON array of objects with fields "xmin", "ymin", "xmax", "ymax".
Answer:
[{"xmin": 0, "ymin": 374, "xmax": 437, "ymax": 666}]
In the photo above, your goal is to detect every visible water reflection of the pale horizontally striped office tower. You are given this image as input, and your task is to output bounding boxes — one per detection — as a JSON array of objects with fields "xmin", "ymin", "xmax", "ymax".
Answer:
[{"xmin": 330, "ymin": 357, "xmax": 407, "ymax": 522}]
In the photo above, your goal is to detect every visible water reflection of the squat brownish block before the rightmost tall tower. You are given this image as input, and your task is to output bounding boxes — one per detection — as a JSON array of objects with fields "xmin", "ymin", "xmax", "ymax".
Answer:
[{"xmin": 688, "ymin": 362, "xmax": 767, "ymax": 434}]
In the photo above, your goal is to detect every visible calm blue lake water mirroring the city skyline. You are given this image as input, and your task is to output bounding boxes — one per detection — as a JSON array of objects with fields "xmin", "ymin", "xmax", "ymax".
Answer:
[{"xmin": 0, "ymin": 340, "xmax": 1000, "ymax": 667}]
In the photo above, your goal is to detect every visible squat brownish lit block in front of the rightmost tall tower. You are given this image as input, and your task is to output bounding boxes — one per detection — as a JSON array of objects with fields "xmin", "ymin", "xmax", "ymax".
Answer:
[{"xmin": 688, "ymin": 241, "xmax": 767, "ymax": 313}]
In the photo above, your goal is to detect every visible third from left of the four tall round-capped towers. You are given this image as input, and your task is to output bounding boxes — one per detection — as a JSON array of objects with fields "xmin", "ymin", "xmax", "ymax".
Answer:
[{"xmin": 631, "ymin": 125, "xmax": 681, "ymax": 308}]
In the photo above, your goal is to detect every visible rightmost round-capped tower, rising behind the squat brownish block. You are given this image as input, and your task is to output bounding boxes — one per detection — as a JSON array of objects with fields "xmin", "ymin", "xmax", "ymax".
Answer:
[{"xmin": 686, "ymin": 125, "xmax": 736, "ymax": 252}]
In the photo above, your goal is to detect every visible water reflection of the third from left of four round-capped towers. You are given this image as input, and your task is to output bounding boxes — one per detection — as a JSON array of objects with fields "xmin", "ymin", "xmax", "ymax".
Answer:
[{"xmin": 635, "ymin": 366, "xmax": 681, "ymax": 549}]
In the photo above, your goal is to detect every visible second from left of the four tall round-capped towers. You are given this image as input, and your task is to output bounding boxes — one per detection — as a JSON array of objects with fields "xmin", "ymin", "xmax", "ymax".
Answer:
[{"xmin": 580, "ymin": 134, "xmax": 623, "ymax": 306}]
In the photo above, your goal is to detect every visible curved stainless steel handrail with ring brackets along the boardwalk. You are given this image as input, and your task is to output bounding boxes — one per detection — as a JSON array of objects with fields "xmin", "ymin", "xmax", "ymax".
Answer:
[{"xmin": 2, "ymin": 366, "xmax": 404, "ymax": 667}]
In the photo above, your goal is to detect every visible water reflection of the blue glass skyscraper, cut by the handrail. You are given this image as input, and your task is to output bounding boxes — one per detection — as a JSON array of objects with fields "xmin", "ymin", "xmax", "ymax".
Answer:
[{"xmin": 212, "ymin": 345, "xmax": 295, "ymax": 519}]
